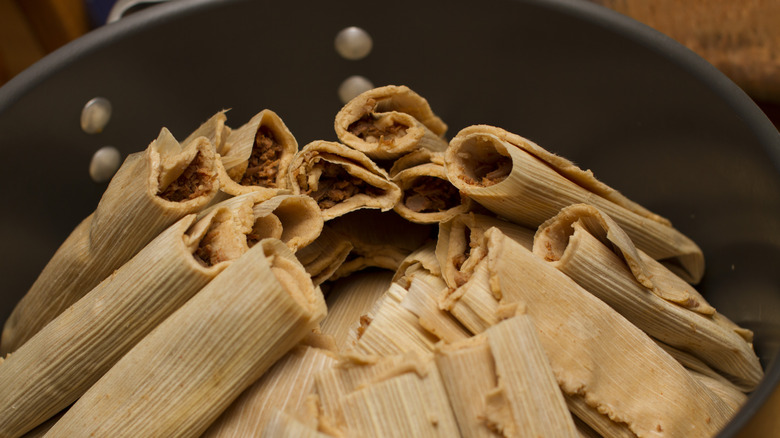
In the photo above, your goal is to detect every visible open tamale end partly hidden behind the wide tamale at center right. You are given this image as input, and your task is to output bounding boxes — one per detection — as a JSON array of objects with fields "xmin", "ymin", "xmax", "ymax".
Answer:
[{"xmin": 436, "ymin": 213, "xmax": 534, "ymax": 289}]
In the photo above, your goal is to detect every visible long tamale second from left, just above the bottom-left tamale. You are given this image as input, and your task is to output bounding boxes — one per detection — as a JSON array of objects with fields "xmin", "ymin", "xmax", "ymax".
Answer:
[{"xmin": 0, "ymin": 207, "xmax": 260, "ymax": 436}]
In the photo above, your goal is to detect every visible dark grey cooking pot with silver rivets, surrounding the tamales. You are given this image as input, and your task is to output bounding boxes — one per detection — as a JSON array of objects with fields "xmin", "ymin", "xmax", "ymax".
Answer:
[{"xmin": 0, "ymin": 0, "xmax": 780, "ymax": 437}]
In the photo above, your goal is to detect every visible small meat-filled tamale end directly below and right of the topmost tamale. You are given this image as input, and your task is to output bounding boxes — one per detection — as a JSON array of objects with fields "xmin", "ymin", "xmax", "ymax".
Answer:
[{"xmin": 392, "ymin": 163, "xmax": 472, "ymax": 224}]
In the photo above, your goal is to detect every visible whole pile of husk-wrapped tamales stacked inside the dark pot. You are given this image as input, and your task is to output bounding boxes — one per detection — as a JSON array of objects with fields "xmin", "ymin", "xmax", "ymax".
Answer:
[{"xmin": 0, "ymin": 86, "xmax": 763, "ymax": 438}]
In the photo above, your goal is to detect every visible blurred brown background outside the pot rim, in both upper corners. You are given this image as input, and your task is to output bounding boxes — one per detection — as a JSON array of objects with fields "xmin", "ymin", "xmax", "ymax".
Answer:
[{"xmin": 0, "ymin": 0, "xmax": 780, "ymax": 126}]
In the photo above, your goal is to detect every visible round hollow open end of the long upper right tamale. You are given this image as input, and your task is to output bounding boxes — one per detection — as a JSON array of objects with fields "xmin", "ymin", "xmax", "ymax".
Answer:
[{"xmin": 450, "ymin": 136, "xmax": 512, "ymax": 187}]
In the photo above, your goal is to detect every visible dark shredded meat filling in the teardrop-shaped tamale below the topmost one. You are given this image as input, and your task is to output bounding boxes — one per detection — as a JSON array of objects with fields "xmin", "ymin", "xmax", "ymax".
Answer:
[{"xmin": 303, "ymin": 161, "xmax": 384, "ymax": 210}]
